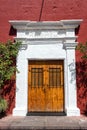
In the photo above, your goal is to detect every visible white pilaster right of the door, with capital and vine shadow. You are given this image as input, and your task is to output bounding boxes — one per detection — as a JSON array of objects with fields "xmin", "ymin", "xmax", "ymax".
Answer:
[{"xmin": 64, "ymin": 43, "xmax": 80, "ymax": 116}]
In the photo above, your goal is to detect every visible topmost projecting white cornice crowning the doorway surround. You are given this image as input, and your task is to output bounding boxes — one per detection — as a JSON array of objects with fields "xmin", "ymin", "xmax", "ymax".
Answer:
[{"xmin": 9, "ymin": 19, "xmax": 83, "ymax": 30}]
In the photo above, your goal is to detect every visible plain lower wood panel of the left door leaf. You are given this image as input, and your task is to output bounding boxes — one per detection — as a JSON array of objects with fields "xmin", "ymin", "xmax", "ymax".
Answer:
[{"xmin": 28, "ymin": 88, "xmax": 45, "ymax": 111}]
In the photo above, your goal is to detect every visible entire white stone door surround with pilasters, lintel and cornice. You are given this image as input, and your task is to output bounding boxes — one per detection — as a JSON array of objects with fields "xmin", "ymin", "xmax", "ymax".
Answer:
[{"xmin": 9, "ymin": 19, "xmax": 82, "ymax": 116}]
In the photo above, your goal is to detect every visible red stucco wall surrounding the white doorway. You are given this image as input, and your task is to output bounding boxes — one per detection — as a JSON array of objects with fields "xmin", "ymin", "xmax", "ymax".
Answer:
[{"xmin": 0, "ymin": 0, "xmax": 87, "ymax": 115}]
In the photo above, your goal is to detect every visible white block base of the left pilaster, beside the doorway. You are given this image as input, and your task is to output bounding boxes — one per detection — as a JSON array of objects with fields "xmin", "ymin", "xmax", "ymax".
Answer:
[{"xmin": 13, "ymin": 108, "xmax": 27, "ymax": 116}]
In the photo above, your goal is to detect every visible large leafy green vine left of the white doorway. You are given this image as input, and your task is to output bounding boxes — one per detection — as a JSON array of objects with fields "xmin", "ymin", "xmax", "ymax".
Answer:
[{"xmin": 0, "ymin": 41, "xmax": 21, "ymax": 88}]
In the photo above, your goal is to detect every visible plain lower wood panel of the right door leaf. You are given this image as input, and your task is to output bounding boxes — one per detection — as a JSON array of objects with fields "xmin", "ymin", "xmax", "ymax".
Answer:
[{"xmin": 46, "ymin": 88, "xmax": 63, "ymax": 112}]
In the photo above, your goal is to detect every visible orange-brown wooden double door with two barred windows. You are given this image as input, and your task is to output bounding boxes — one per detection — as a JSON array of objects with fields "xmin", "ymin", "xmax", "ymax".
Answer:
[{"xmin": 28, "ymin": 60, "xmax": 64, "ymax": 112}]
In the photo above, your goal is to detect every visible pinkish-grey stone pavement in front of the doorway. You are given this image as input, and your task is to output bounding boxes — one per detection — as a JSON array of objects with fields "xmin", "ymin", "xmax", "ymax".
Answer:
[{"xmin": 0, "ymin": 116, "xmax": 87, "ymax": 130}]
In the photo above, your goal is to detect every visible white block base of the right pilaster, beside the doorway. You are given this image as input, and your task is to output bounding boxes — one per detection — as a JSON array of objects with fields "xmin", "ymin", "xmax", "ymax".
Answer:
[{"xmin": 66, "ymin": 108, "xmax": 80, "ymax": 116}]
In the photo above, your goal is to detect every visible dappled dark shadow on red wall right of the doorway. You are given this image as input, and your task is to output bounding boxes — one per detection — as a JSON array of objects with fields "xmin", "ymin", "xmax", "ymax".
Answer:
[{"xmin": 76, "ymin": 60, "xmax": 87, "ymax": 116}]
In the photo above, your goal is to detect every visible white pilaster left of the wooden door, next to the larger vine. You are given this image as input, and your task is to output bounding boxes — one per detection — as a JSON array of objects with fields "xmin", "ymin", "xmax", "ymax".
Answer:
[{"xmin": 13, "ymin": 46, "xmax": 28, "ymax": 116}]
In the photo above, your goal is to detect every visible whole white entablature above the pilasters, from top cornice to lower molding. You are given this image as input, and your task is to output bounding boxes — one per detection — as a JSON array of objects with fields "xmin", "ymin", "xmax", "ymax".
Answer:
[{"xmin": 9, "ymin": 19, "xmax": 82, "ymax": 43}]
